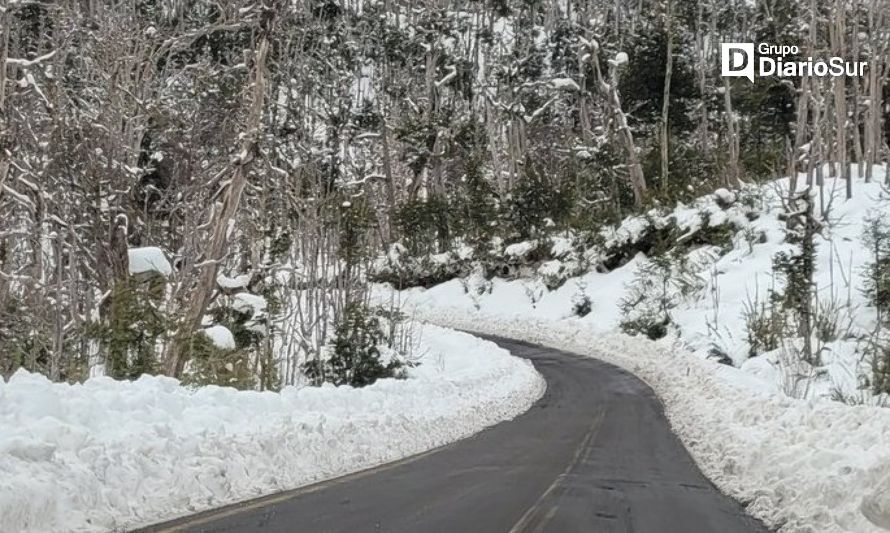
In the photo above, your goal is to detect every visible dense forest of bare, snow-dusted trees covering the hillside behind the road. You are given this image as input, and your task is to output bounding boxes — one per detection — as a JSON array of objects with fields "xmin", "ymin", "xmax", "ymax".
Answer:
[{"xmin": 0, "ymin": 0, "xmax": 890, "ymax": 389}]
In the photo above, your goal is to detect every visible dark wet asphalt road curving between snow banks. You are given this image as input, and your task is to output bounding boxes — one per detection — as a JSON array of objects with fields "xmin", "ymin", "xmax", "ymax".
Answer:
[{"xmin": 137, "ymin": 338, "xmax": 767, "ymax": 533}]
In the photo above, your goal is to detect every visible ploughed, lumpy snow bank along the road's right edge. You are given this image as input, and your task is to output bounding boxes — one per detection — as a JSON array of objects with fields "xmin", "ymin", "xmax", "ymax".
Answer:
[{"xmin": 386, "ymin": 300, "xmax": 890, "ymax": 533}]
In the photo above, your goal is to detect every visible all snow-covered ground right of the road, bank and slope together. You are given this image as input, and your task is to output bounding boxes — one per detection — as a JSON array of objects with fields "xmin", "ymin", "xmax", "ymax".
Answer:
[{"xmin": 376, "ymin": 169, "xmax": 890, "ymax": 533}]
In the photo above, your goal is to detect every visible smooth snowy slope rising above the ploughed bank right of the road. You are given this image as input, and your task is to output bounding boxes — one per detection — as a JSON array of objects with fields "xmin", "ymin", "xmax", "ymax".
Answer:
[{"xmin": 380, "ymin": 167, "xmax": 890, "ymax": 402}]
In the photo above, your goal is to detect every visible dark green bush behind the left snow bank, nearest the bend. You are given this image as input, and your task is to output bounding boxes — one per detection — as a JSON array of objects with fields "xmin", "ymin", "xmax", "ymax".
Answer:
[{"xmin": 303, "ymin": 302, "xmax": 404, "ymax": 387}]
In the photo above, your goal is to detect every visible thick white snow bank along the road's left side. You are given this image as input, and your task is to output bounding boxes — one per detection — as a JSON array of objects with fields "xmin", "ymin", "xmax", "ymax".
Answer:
[{"xmin": 0, "ymin": 326, "xmax": 545, "ymax": 532}]
